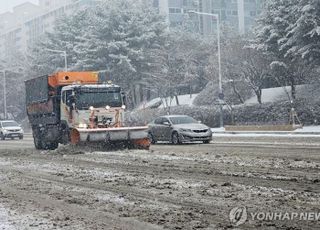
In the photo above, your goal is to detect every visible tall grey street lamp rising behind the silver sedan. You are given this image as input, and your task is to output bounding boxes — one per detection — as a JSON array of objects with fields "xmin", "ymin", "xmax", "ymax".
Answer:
[{"xmin": 189, "ymin": 11, "xmax": 224, "ymax": 128}]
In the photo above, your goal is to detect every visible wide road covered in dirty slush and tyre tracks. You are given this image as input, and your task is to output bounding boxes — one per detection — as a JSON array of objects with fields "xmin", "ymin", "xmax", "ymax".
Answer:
[{"xmin": 0, "ymin": 136, "xmax": 320, "ymax": 230}]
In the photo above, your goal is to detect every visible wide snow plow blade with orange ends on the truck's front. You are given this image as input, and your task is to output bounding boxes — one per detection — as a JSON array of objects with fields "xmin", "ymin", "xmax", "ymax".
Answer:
[{"xmin": 71, "ymin": 126, "xmax": 150, "ymax": 149}]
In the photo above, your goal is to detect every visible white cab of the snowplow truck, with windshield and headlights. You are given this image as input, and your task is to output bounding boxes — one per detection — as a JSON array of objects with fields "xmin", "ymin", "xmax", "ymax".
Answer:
[{"xmin": 60, "ymin": 83, "xmax": 126, "ymax": 129}]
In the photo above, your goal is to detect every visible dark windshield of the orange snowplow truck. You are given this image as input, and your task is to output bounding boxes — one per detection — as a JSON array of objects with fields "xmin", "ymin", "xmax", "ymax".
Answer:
[{"xmin": 76, "ymin": 91, "xmax": 122, "ymax": 110}]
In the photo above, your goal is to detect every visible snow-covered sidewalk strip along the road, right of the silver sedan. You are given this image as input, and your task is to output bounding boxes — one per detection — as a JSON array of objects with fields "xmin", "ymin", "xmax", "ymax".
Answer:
[{"xmin": 211, "ymin": 126, "xmax": 320, "ymax": 138}]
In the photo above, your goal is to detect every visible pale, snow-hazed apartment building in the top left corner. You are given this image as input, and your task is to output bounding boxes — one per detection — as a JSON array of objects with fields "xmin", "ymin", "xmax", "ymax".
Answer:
[{"xmin": 0, "ymin": 0, "xmax": 96, "ymax": 58}]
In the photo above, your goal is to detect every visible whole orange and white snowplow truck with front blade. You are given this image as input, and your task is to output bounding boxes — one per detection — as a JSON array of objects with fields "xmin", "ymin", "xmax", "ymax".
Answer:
[{"xmin": 25, "ymin": 72, "xmax": 150, "ymax": 150}]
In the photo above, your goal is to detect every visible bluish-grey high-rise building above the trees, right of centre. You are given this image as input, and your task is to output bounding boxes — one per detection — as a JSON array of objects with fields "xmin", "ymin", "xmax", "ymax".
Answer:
[{"xmin": 153, "ymin": 0, "xmax": 265, "ymax": 35}]
